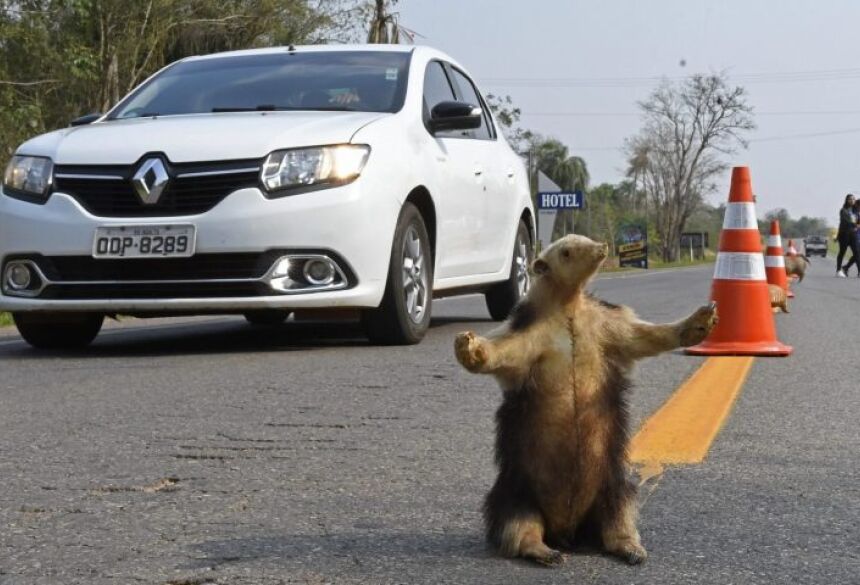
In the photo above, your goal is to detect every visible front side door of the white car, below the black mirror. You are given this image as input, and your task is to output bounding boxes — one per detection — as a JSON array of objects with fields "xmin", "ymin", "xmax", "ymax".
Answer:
[{"xmin": 423, "ymin": 61, "xmax": 485, "ymax": 279}]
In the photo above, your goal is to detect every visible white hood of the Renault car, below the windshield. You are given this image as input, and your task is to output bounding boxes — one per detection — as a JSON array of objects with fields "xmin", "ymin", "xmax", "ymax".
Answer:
[{"xmin": 18, "ymin": 112, "xmax": 392, "ymax": 165}]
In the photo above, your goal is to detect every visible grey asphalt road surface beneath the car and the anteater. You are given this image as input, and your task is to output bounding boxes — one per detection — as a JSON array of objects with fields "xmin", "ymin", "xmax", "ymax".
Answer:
[{"xmin": 0, "ymin": 259, "xmax": 860, "ymax": 585}]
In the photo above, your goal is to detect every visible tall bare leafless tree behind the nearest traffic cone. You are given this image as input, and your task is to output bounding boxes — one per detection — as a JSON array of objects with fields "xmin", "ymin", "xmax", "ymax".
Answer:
[{"xmin": 627, "ymin": 74, "xmax": 755, "ymax": 262}]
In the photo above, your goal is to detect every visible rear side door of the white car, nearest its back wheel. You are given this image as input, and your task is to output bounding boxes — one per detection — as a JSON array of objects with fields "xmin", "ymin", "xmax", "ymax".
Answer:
[{"xmin": 451, "ymin": 67, "xmax": 516, "ymax": 273}]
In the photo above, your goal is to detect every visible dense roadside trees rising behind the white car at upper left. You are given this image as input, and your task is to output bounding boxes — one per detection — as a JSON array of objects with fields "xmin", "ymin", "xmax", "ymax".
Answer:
[{"xmin": 0, "ymin": 0, "xmax": 358, "ymax": 159}]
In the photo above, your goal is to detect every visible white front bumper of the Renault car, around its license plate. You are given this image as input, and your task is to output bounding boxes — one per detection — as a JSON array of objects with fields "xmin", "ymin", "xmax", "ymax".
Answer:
[{"xmin": 0, "ymin": 182, "xmax": 397, "ymax": 313}]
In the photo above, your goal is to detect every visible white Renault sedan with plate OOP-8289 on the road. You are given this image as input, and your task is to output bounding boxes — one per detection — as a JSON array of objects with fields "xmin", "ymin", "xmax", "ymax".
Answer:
[{"xmin": 0, "ymin": 45, "xmax": 535, "ymax": 347}]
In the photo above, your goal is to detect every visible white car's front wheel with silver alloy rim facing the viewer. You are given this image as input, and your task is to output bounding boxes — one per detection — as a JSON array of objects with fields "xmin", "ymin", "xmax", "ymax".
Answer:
[{"xmin": 361, "ymin": 203, "xmax": 433, "ymax": 345}]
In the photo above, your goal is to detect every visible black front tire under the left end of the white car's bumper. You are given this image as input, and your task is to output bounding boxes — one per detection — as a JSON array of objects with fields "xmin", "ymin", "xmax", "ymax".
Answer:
[{"xmin": 12, "ymin": 313, "xmax": 104, "ymax": 349}]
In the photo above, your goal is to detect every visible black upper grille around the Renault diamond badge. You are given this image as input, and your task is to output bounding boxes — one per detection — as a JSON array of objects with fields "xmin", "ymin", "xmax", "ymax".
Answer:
[{"xmin": 53, "ymin": 159, "xmax": 261, "ymax": 217}]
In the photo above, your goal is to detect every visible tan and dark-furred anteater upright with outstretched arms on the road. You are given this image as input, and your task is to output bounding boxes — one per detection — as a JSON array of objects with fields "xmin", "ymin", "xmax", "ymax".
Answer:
[{"xmin": 455, "ymin": 236, "xmax": 716, "ymax": 565}]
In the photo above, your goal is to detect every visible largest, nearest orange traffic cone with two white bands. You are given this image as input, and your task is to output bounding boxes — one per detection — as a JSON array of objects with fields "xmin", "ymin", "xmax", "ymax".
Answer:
[{"xmin": 686, "ymin": 167, "xmax": 792, "ymax": 356}]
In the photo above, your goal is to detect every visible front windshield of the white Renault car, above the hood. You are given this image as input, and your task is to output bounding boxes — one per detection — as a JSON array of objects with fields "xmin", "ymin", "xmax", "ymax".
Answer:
[{"xmin": 108, "ymin": 50, "xmax": 410, "ymax": 120}]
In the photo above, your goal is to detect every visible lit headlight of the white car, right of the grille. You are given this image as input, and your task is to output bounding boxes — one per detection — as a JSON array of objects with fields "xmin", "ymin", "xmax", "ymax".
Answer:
[{"xmin": 260, "ymin": 144, "xmax": 370, "ymax": 196}]
